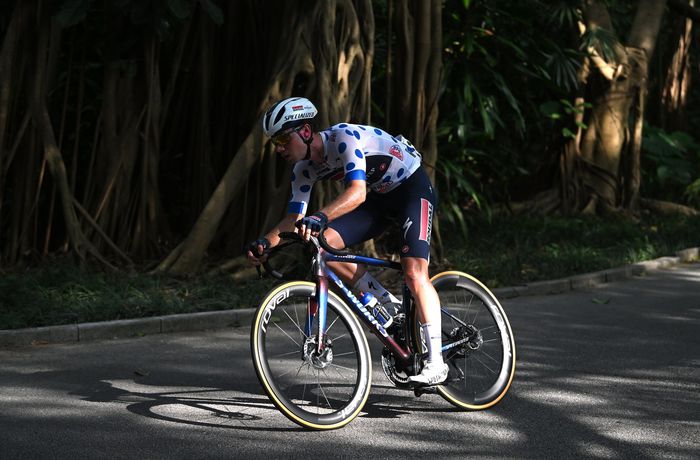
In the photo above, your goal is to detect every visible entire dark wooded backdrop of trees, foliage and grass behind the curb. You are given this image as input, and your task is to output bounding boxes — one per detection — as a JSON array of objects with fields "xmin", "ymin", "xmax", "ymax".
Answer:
[{"xmin": 0, "ymin": 0, "xmax": 700, "ymax": 327}]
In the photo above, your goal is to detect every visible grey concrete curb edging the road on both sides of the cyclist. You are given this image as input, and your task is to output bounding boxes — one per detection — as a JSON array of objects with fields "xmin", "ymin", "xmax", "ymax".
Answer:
[{"xmin": 0, "ymin": 247, "xmax": 700, "ymax": 349}]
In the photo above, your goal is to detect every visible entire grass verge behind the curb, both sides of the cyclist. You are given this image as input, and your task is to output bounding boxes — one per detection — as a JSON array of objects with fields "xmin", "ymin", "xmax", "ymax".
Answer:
[{"xmin": 5, "ymin": 216, "xmax": 700, "ymax": 329}]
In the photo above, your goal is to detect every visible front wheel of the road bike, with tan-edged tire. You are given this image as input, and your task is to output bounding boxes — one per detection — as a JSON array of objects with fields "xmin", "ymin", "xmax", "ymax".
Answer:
[{"xmin": 250, "ymin": 281, "xmax": 372, "ymax": 430}]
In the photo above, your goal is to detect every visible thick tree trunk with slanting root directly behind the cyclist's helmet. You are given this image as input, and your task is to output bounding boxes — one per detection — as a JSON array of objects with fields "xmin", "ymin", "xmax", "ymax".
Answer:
[{"xmin": 157, "ymin": 0, "xmax": 374, "ymax": 274}]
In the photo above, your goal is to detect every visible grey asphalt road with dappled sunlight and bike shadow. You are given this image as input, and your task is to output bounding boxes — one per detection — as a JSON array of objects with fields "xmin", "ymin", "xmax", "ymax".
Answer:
[{"xmin": 0, "ymin": 264, "xmax": 700, "ymax": 459}]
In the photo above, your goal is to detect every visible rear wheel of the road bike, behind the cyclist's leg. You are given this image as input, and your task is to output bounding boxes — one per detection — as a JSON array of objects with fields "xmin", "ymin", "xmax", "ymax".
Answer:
[{"xmin": 414, "ymin": 271, "xmax": 515, "ymax": 410}]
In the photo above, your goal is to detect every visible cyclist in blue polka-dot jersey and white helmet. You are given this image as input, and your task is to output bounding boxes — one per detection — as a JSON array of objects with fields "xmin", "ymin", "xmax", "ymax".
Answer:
[{"xmin": 247, "ymin": 97, "xmax": 448, "ymax": 385}]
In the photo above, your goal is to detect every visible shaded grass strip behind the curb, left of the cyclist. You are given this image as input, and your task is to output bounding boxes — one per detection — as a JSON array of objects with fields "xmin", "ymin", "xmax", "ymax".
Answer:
[{"xmin": 0, "ymin": 262, "xmax": 269, "ymax": 329}]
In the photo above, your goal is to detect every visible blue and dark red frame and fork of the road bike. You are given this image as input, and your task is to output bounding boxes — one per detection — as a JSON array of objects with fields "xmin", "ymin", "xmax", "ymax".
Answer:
[{"xmin": 304, "ymin": 251, "xmax": 413, "ymax": 364}]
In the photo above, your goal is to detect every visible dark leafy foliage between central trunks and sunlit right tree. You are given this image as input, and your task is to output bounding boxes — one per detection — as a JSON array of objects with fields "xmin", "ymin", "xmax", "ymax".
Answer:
[{"xmin": 437, "ymin": 0, "xmax": 581, "ymax": 235}]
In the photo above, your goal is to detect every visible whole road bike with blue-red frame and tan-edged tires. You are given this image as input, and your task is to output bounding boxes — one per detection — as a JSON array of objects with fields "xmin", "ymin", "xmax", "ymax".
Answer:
[{"xmin": 250, "ymin": 233, "xmax": 515, "ymax": 430}]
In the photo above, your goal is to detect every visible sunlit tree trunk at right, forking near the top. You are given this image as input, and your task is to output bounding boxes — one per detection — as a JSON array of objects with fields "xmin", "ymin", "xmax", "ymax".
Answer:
[{"xmin": 565, "ymin": 0, "xmax": 665, "ymax": 213}]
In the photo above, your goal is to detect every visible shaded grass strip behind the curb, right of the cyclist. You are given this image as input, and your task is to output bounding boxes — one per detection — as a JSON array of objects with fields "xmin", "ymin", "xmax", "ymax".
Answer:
[{"xmin": 444, "ymin": 216, "xmax": 700, "ymax": 287}]
